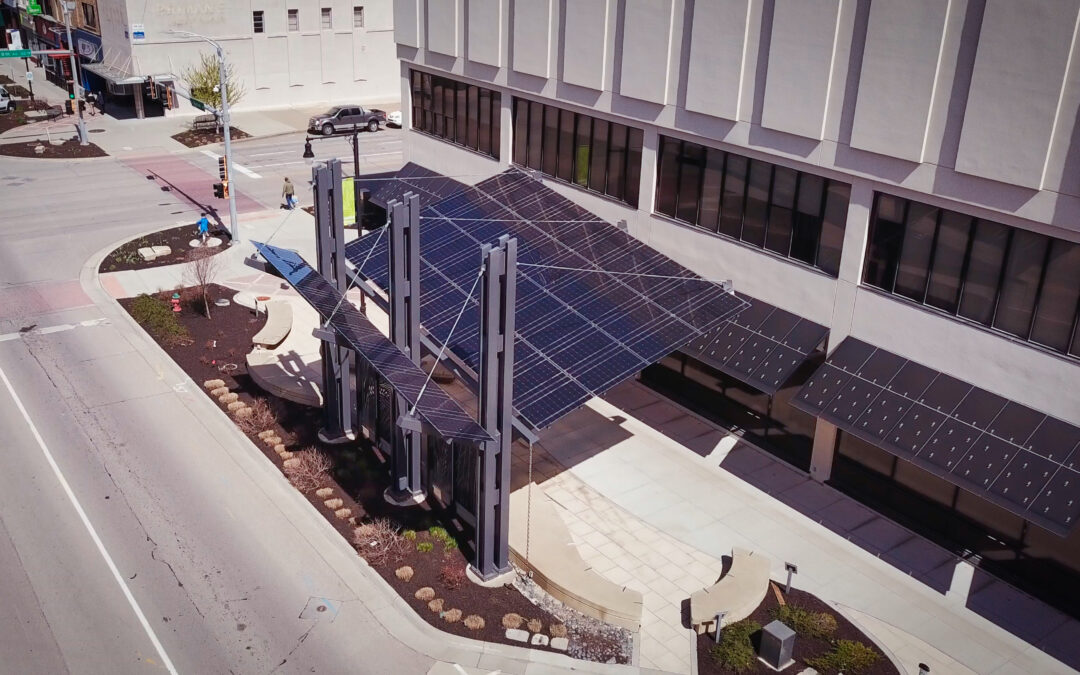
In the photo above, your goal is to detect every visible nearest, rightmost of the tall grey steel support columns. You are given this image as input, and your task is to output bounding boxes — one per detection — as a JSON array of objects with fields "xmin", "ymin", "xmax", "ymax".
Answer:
[{"xmin": 472, "ymin": 235, "xmax": 517, "ymax": 581}]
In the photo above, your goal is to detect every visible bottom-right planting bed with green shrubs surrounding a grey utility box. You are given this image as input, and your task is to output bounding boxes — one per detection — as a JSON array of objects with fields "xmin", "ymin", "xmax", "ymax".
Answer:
[{"xmin": 698, "ymin": 583, "xmax": 900, "ymax": 675}]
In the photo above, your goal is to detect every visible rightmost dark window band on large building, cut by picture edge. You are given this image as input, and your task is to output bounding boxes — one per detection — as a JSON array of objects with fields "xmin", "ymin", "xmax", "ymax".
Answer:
[{"xmin": 863, "ymin": 193, "xmax": 1080, "ymax": 356}]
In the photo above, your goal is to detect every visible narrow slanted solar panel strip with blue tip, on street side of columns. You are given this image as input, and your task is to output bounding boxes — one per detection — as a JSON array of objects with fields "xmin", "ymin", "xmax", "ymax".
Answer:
[{"xmin": 253, "ymin": 242, "xmax": 491, "ymax": 442}]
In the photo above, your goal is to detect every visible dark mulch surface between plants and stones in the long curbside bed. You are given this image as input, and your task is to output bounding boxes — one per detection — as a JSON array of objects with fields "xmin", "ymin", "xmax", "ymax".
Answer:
[{"xmin": 120, "ymin": 285, "xmax": 626, "ymax": 663}]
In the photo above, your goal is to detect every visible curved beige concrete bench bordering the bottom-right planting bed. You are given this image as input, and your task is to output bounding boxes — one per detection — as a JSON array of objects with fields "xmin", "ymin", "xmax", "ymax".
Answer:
[{"xmin": 690, "ymin": 549, "xmax": 770, "ymax": 635}]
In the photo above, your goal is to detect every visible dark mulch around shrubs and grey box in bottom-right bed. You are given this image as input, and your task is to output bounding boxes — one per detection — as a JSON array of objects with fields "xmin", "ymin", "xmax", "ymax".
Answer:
[{"xmin": 698, "ymin": 584, "xmax": 900, "ymax": 675}]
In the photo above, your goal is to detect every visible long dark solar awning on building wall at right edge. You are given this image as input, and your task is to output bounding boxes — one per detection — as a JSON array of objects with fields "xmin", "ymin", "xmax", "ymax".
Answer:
[{"xmin": 792, "ymin": 337, "xmax": 1080, "ymax": 536}]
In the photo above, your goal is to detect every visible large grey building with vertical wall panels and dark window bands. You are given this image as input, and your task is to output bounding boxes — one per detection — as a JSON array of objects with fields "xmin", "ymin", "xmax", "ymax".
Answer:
[{"xmin": 393, "ymin": 0, "xmax": 1080, "ymax": 626}]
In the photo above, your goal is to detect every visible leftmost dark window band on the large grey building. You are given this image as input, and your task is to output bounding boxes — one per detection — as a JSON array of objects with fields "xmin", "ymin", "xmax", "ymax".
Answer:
[{"xmin": 409, "ymin": 70, "xmax": 501, "ymax": 159}]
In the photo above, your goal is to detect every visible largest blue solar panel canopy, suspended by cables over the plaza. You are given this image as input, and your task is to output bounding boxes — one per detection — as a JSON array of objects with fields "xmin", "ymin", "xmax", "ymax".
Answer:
[{"xmin": 346, "ymin": 168, "xmax": 746, "ymax": 429}]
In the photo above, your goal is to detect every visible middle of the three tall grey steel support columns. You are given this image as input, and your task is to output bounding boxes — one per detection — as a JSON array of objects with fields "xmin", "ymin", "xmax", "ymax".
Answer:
[{"xmin": 386, "ymin": 192, "xmax": 423, "ymax": 504}]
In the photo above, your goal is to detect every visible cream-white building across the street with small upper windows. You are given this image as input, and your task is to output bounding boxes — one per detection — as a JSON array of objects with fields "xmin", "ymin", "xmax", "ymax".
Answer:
[{"xmin": 14, "ymin": 0, "xmax": 400, "ymax": 117}]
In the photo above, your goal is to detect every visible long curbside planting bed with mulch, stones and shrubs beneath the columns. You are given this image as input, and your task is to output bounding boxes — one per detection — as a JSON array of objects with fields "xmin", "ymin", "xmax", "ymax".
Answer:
[{"xmin": 120, "ymin": 285, "xmax": 632, "ymax": 663}]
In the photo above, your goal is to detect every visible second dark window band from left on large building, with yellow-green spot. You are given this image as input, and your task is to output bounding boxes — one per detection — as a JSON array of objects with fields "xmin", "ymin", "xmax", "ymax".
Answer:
[{"xmin": 507, "ymin": 98, "xmax": 645, "ymax": 206}]
